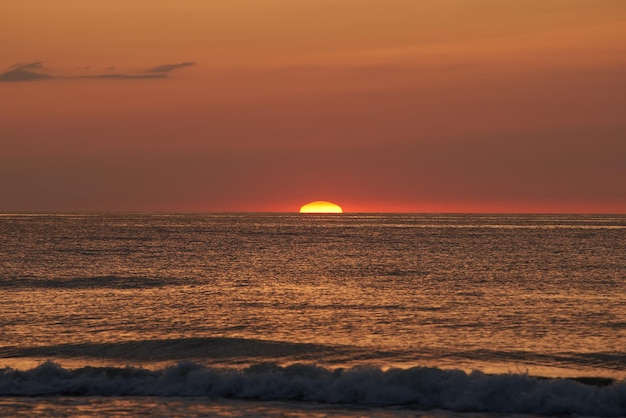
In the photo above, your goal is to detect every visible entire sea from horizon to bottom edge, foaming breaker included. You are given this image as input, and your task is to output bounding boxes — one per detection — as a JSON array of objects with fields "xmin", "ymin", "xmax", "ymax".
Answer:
[{"xmin": 0, "ymin": 214, "xmax": 626, "ymax": 417}]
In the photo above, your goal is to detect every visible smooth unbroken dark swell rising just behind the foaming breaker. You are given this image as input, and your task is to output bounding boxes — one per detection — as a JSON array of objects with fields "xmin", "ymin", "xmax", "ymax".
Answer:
[{"xmin": 6, "ymin": 336, "xmax": 626, "ymax": 375}]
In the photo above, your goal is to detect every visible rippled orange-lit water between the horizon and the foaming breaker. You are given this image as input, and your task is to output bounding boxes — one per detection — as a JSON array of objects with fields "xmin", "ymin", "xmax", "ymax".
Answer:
[{"xmin": 0, "ymin": 214, "xmax": 626, "ymax": 412}]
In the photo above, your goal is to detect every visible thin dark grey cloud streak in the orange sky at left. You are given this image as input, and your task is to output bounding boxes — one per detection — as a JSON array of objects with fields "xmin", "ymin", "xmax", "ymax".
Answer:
[{"xmin": 0, "ymin": 61, "xmax": 195, "ymax": 83}]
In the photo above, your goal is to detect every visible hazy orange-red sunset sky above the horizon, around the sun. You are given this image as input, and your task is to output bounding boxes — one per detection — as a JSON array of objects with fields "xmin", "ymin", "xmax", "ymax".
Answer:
[{"xmin": 0, "ymin": 0, "xmax": 626, "ymax": 213}]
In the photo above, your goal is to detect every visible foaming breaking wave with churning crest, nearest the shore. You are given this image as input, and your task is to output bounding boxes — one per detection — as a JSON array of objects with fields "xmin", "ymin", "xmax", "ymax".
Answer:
[{"xmin": 0, "ymin": 362, "xmax": 626, "ymax": 416}]
